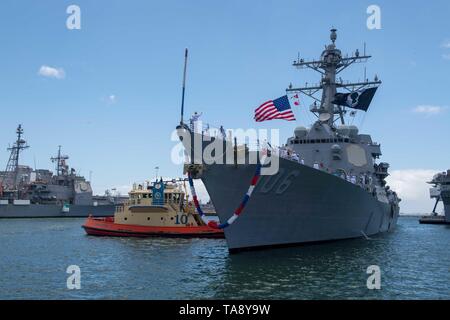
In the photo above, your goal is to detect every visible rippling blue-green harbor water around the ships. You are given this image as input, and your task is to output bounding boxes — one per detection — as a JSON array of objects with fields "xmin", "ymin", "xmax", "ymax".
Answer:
[{"xmin": 0, "ymin": 218, "xmax": 450, "ymax": 299}]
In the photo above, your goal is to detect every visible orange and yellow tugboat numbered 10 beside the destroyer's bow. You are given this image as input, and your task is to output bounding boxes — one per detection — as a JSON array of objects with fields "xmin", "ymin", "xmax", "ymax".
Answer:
[{"xmin": 83, "ymin": 179, "xmax": 224, "ymax": 238}]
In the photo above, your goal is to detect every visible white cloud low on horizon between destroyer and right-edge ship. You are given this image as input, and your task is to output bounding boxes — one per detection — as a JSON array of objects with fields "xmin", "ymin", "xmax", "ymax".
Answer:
[{"xmin": 386, "ymin": 169, "xmax": 442, "ymax": 214}]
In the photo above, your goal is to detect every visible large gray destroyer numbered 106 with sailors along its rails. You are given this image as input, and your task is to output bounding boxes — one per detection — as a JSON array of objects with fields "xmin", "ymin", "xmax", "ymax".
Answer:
[{"xmin": 177, "ymin": 29, "xmax": 401, "ymax": 252}]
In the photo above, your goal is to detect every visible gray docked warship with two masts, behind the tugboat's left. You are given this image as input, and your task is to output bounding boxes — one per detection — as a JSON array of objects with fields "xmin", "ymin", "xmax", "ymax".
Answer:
[{"xmin": 0, "ymin": 125, "xmax": 125, "ymax": 218}]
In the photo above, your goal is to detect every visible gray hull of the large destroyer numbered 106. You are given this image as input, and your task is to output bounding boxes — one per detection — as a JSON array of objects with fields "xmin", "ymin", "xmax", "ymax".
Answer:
[{"xmin": 201, "ymin": 159, "xmax": 399, "ymax": 252}]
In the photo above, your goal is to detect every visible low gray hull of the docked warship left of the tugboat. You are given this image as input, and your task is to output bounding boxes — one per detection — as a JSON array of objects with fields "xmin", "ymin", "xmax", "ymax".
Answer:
[{"xmin": 0, "ymin": 204, "xmax": 116, "ymax": 219}]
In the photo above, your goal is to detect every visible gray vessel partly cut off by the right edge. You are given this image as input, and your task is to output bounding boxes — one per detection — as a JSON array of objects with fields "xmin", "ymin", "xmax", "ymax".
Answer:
[{"xmin": 419, "ymin": 170, "xmax": 450, "ymax": 224}]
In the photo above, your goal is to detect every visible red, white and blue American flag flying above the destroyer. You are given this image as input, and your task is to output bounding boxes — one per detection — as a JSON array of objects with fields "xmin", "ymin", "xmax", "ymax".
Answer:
[{"xmin": 255, "ymin": 96, "xmax": 295, "ymax": 122}]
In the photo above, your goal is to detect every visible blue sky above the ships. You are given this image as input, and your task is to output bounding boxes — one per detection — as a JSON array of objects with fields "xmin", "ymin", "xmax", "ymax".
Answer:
[{"xmin": 0, "ymin": 0, "xmax": 450, "ymax": 211}]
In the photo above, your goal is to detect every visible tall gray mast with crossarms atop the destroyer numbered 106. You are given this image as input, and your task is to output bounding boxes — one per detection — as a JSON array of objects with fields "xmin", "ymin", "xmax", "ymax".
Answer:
[{"xmin": 286, "ymin": 29, "xmax": 381, "ymax": 126}]
